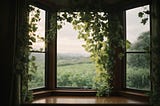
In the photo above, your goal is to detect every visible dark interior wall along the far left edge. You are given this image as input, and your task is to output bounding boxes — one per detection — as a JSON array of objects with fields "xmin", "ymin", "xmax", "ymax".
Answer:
[{"xmin": 0, "ymin": 0, "xmax": 15, "ymax": 106}]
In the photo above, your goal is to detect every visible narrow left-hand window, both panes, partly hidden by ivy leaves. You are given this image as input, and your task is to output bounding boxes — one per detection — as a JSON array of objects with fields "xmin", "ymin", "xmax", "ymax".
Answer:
[{"xmin": 28, "ymin": 7, "xmax": 46, "ymax": 89}]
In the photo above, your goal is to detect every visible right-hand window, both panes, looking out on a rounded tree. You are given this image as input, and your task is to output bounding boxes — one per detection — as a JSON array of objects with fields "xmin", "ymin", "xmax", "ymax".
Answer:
[{"xmin": 126, "ymin": 5, "xmax": 150, "ymax": 90}]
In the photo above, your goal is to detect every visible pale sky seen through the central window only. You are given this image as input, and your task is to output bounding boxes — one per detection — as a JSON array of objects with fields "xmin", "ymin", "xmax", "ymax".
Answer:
[{"xmin": 57, "ymin": 22, "xmax": 88, "ymax": 54}]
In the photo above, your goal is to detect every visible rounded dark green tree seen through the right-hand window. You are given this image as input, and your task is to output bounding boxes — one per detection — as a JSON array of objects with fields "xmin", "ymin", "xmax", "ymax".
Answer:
[{"xmin": 127, "ymin": 31, "xmax": 150, "ymax": 68}]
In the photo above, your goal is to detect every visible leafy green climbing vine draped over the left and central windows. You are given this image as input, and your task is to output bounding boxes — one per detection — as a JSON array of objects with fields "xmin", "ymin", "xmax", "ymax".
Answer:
[{"xmin": 16, "ymin": 2, "xmax": 124, "ymax": 102}]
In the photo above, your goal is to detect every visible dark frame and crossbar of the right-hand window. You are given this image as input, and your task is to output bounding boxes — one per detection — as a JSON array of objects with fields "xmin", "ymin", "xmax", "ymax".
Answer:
[{"xmin": 122, "ymin": 3, "xmax": 152, "ymax": 94}]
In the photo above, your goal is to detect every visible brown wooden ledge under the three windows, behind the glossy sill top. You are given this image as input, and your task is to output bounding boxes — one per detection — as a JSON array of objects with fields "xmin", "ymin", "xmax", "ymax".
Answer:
[{"xmin": 33, "ymin": 89, "xmax": 149, "ymax": 102}]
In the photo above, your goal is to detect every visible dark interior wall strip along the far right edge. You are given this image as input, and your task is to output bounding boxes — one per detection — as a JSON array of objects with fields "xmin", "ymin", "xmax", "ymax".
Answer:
[{"xmin": 151, "ymin": 0, "xmax": 160, "ymax": 106}]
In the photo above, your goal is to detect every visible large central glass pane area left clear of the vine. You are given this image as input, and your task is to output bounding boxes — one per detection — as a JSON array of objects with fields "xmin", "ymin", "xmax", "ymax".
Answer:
[{"xmin": 57, "ymin": 22, "xmax": 95, "ymax": 88}]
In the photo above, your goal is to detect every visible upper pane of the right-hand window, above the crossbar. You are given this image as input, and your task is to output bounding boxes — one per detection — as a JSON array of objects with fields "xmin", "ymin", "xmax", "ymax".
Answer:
[{"xmin": 126, "ymin": 5, "xmax": 150, "ymax": 51}]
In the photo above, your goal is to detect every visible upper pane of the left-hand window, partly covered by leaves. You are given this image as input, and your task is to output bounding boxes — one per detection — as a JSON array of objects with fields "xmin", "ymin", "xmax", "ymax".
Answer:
[{"xmin": 30, "ymin": 7, "xmax": 46, "ymax": 51}]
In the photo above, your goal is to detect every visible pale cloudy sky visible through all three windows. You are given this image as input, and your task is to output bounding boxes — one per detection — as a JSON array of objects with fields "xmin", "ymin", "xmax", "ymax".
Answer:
[{"xmin": 34, "ymin": 4, "xmax": 149, "ymax": 55}]
